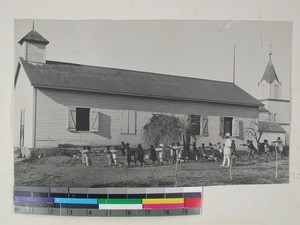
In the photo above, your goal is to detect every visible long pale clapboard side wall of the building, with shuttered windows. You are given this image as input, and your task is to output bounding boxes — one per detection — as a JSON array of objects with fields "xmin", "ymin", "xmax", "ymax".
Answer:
[{"xmin": 36, "ymin": 88, "xmax": 258, "ymax": 147}]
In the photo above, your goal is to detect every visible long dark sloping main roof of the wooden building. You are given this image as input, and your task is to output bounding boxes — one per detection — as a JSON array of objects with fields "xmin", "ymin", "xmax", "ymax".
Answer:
[{"xmin": 20, "ymin": 58, "xmax": 263, "ymax": 106}]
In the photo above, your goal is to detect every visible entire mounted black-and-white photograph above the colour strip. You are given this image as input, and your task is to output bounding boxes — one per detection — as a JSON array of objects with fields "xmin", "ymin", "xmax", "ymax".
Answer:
[{"xmin": 13, "ymin": 19, "xmax": 293, "ymax": 188}]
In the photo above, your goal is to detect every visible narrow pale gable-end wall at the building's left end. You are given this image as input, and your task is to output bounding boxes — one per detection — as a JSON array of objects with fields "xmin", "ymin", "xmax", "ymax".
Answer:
[{"xmin": 14, "ymin": 66, "xmax": 33, "ymax": 148}]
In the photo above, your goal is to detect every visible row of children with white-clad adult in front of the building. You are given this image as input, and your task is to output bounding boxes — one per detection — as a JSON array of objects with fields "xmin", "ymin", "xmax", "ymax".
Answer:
[{"xmin": 82, "ymin": 133, "xmax": 283, "ymax": 167}]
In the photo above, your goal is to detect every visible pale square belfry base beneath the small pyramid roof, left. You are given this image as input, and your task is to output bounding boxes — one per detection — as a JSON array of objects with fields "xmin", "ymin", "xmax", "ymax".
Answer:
[{"xmin": 25, "ymin": 43, "xmax": 46, "ymax": 63}]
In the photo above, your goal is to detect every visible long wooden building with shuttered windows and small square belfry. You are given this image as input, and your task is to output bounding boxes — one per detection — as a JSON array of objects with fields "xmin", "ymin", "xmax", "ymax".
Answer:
[{"xmin": 14, "ymin": 29, "xmax": 262, "ymax": 148}]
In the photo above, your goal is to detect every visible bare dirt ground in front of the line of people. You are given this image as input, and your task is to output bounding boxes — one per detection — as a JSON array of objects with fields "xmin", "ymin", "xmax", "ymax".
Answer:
[{"xmin": 15, "ymin": 153, "xmax": 289, "ymax": 187}]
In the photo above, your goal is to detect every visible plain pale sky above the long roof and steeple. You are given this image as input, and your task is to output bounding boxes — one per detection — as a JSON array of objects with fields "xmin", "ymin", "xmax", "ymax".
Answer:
[{"xmin": 15, "ymin": 20, "xmax": 292, "ymax": 99}]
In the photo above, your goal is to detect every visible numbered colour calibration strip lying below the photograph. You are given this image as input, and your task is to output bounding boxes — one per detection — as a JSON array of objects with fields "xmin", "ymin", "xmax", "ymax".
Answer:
[{"xmin": 14, "ymin": 186, "xmax": 202, "ymax": 217}]
